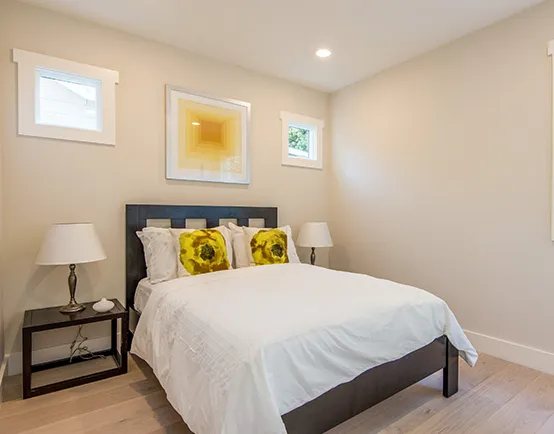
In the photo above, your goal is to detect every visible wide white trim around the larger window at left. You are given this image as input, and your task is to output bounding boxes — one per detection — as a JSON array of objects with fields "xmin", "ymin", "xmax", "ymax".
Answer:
[{"xmin": 13, "ymin": 48, "xmax": 119, "ymax": 146}]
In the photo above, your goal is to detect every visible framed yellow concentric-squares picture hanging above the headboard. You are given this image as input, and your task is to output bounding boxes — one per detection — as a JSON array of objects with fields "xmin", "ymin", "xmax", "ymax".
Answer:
[{"xmin": 166, "ymin": 86, "xmax": 250, "ymax": 184}]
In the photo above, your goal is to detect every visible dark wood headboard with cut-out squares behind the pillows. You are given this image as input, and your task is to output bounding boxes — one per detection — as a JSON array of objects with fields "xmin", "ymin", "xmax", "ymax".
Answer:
[{"xmin": 125, "ymin": 205, "xmax": 278, "ymax": 308}]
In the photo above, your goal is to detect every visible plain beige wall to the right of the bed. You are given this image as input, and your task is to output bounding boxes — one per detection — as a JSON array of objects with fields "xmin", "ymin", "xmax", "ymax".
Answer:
[{"xmin": 330, "ymin": 1, "xmax": 554, "ymax": 352}]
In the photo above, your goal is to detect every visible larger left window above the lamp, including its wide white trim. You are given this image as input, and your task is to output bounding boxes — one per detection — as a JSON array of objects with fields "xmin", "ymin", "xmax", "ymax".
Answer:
[{"xmin": 14, "ymin": 49, "xmax": 119, "ymax": 145}]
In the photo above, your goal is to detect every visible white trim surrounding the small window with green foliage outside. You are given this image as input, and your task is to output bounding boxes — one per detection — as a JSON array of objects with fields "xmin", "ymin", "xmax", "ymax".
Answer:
[{"xmin": 281, "ymin": 111, "xmax": 325, "ymax": 170}]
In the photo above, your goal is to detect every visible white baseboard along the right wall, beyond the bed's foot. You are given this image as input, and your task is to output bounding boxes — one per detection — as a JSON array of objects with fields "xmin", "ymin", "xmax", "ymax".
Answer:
[{"xmin": 465, "ymin": 330, "xmax": 554, "ymax": 375}]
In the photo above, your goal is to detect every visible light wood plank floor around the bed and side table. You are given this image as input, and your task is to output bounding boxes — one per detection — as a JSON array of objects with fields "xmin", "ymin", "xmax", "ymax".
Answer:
[{"xmin": 0, "ymin": 355, "xmax": 554, "ymax": 434}]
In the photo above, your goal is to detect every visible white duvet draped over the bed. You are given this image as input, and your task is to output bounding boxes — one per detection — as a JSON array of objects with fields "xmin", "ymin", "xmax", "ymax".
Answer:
[{"xmin": 132, "ymin": 264, "xmax": 477, "ymax": 434}]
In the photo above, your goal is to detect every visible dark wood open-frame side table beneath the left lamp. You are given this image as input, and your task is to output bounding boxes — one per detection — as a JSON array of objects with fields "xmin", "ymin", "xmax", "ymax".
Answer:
[{"xmin": 23, "ymin": 299, "xmax": 129, "ymax": 399}]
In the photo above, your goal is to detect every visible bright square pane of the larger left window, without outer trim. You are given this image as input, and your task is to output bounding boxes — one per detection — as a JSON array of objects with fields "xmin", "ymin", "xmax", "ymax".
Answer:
[{"xmin": 35, "ymin": 68, "xmax": 102, "ymax": 131}]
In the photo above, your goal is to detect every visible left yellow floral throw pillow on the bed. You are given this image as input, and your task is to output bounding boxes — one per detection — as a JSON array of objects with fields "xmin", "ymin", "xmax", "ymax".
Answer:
[{"xmin": 179, "ymin": 229, "xmax": 231, "ymax": 276}]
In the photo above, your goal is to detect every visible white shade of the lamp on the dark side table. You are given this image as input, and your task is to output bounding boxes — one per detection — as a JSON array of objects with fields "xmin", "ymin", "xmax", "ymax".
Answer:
[{"xmin": 36, "ymin": 223, "xmax": 106, "ymax": 265}]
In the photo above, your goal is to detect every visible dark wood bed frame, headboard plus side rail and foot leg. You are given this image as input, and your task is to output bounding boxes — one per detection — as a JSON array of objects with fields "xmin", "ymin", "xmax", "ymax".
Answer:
[{"xmin": 125, "ymin": 205, "xmax": 458, "ymax": 434}]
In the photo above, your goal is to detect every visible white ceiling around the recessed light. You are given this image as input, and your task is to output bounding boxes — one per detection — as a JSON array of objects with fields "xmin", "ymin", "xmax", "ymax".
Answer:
[{"xmin": 22, "ymin": 0, "xmax": 543, "ymax": 91}]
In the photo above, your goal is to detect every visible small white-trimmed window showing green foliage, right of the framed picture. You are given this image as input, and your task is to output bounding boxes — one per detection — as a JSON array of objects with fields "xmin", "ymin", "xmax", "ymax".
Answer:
[{"xmin": 281, "ymin": 112, "xmax": 324, "ymax": 169}]
